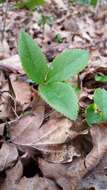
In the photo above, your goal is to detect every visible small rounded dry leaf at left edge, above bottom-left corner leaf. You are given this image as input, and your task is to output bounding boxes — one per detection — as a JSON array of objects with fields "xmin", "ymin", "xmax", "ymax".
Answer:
[{"xmin": 0, "ymin": 143, "xmax": 18, "ymax": 172}]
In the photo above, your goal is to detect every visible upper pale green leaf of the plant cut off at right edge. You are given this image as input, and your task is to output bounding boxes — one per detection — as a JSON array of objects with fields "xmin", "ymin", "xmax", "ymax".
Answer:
[{"xmin": 94, "ymin": 88, "xmax": 107, "ymax": 118}]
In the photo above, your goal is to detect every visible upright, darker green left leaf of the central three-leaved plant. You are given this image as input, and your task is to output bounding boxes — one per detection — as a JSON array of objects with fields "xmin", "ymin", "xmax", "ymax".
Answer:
[{"xmin": 18, "ymin": 32, "xmax": 48, "ymax": 84}]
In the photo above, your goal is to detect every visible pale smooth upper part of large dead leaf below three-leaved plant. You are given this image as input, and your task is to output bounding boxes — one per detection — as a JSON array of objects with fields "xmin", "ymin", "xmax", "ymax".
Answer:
[{"xmin": 11, "ymin": 119, "xmax": 72, "ymax": 148}]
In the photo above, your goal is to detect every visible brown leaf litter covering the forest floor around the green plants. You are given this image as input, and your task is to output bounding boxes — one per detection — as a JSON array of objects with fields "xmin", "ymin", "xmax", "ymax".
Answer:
[{"xmin": 0, "ymin": 1, "xmax": 107, "ymax": 190}]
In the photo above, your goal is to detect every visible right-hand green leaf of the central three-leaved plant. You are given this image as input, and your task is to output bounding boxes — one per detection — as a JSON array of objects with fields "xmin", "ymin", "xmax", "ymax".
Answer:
[{"xmin": 47, "ymin": 49, "xmax": 88, "ymax": 82}]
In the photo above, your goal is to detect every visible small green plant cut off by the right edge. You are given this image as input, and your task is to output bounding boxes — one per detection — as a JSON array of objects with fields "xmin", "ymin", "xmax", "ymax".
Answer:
[{"xmin": 86, "ymin": 88, "xmax": 107, "ymax": 126}]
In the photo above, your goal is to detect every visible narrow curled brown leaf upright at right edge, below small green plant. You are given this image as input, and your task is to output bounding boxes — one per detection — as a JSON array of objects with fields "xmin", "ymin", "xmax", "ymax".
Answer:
[{"xmin": 85, "ymin": 123, "xmax": 107, "ymax": 170}]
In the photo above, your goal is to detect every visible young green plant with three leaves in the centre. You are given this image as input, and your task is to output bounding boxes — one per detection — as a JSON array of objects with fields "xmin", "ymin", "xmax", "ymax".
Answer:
[{"xmin": 18, "ymin": 32, "xmax": 88, "ymax": 120}]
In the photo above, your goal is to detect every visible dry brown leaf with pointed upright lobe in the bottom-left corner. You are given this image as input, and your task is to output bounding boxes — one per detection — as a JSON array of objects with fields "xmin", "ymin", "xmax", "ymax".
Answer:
[{"xmin": 0, "ymin": 161, "xmax": 59, "ymax": 190}]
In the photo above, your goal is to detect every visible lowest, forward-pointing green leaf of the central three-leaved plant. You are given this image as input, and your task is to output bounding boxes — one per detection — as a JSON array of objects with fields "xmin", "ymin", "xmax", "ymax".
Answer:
[{"xmin": 39, "ymin": 82, "xmax": 78, "ymax": 120}]
